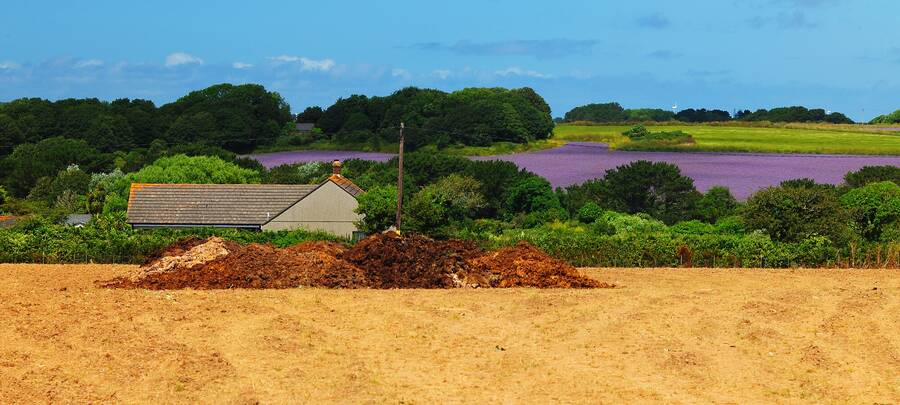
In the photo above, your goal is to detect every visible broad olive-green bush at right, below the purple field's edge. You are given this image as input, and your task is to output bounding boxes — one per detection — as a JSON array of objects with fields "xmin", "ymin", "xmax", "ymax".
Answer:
[{"xmin": 743, "ymin": 187, "xmax": 850, "ymax": 243}]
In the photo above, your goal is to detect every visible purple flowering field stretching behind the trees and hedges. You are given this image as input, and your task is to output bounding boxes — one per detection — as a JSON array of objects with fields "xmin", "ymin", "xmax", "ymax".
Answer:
[{"xmin": 251, "ymin": 142, "xmax": 900, "ymax": 200}]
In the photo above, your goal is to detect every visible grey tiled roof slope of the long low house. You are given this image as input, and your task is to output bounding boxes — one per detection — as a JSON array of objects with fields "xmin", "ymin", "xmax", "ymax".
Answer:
[{"xmin": 128, "ymin": 183, "xmax": 318, "ymax": 226}]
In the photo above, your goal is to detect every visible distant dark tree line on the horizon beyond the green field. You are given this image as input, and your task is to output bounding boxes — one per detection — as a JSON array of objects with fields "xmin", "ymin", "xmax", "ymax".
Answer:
[{"xmin": 562, "ymin": 102, "xmax": 853, "ymax": 124}]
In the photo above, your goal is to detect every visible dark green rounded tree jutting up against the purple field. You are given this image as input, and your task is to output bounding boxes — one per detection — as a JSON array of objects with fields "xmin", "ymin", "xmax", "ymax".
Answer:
[{"xmin": 598, "ymin": 160, "xmax": 700, "ymax": 224}]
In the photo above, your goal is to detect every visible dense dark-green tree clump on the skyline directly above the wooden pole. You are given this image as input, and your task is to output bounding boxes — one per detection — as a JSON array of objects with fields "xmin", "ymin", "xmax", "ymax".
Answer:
[{"xmin": 316, "ymin": 87, "xmax": 553, "ymax": 150}]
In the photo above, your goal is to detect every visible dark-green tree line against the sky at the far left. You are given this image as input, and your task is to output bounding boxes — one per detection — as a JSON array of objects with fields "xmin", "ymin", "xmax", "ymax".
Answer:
[{"xmin": 0, "ymin": 84, "xmax": 293, "ymax": 156}]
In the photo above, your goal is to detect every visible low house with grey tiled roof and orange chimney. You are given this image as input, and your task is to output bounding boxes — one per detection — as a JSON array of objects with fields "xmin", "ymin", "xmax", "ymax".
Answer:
[{"xmin": 128, "ymin": 161, "xmax": 363, "ymax": 237}]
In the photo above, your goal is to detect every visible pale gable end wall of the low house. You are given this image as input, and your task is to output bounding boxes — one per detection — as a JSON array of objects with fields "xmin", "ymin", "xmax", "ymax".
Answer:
[{"xmin": 262, "ymin": 181, "xmax": 361, "ymax": 237}]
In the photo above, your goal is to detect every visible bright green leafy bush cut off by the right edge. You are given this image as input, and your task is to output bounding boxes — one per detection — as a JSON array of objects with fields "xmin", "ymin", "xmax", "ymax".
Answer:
[{"xmin": 841, "ymin": 181, "xmax": 900, "ymax": 241}]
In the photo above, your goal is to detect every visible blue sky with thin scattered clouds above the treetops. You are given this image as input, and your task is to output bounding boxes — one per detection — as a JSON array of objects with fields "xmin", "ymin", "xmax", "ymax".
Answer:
[{"xmin": 0, "ymin": 0, "xmax": 900, "ymax": 120}]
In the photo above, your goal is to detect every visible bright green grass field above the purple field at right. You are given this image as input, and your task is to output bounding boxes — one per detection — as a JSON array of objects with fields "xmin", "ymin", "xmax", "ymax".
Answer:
[{"xmin": 553, "ymin": 124, "xmax": 900, "ymax": 155}]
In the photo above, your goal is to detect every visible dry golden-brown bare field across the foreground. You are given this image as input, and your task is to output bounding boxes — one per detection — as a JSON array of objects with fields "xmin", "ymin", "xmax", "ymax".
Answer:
[{"xmin": 0, "ymin": 265, "xmax": 900, "ymax": 404}]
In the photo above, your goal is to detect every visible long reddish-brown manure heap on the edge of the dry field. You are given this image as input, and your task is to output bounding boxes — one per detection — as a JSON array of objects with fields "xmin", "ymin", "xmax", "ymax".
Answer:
[{"xmin": 100, "ymin": 233, "xmax": 613, "ymax": 290}]
